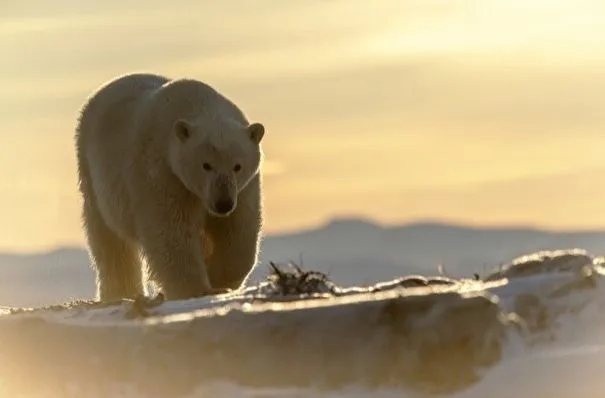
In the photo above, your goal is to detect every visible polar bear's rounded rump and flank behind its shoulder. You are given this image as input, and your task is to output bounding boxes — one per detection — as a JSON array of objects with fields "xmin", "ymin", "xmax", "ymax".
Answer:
[{"xmin": 76, "ymin": 74, "xmax": 169, "ymax": 235}]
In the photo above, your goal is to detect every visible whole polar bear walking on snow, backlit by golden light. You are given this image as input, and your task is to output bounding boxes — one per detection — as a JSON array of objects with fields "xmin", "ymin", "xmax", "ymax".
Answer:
[{"xmin": 75, "ymin": 73, "xmax": 265, "ymax": 301}]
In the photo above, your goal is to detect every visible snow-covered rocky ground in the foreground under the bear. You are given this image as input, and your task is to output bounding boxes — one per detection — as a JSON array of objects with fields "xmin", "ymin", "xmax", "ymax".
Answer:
[{"xmin": 0, "ymin": 249, "xmax": 605, "ymax": 398}]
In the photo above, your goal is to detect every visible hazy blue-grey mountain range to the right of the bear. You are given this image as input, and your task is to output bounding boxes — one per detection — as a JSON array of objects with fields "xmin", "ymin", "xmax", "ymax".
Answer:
[{"xmin": 262, "ymin": 219, "xmax": 605, "ymax": 285}]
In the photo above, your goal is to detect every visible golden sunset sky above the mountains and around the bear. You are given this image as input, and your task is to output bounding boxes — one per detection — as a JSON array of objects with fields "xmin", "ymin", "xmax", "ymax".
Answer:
[{"xmin": 0, "ymin": 0, "xmax": 605, "ymax": 251}]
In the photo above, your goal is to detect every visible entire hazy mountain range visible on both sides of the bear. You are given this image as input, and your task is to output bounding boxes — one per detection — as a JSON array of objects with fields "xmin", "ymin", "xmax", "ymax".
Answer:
[{"xmin": 0, "ymin": 219, "xmax": 605, "ymax": 305}]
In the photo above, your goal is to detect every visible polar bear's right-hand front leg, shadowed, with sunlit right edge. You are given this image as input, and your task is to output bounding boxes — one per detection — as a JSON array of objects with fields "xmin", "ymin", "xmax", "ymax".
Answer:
[{"xmin": 205, "ymin": 204, "xmax": 262, "ymax": 289}]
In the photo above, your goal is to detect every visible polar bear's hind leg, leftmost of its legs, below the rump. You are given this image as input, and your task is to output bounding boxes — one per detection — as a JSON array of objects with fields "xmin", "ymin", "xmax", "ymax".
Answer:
[{"xmin": 83, "ymin": 200, "xmax": 145, "ymax": 301}]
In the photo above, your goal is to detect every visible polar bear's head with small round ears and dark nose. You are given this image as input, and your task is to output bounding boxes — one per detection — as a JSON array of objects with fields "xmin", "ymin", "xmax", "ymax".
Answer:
[{"xmin": 170, "ymin": 119, "xmax": 265, "ymax": 217}]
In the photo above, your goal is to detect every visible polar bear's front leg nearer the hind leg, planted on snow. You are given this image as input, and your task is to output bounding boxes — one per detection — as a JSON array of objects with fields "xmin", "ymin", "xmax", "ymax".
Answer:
[{"xmin": 139, "ymin": 210, "xmax": 224, "ymax": 300}]
